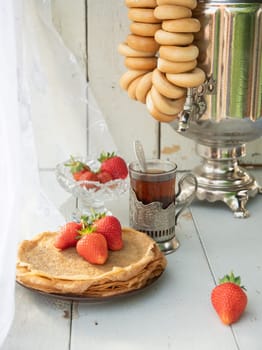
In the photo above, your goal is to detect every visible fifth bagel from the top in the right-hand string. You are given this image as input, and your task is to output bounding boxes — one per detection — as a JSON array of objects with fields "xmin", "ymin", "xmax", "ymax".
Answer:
[{"xmin": 159, "ymin": 45, "xmax": 199, "ymax": 62}]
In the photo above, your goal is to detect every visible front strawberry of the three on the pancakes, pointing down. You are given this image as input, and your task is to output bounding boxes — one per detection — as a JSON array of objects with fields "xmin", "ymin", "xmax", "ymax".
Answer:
[{"xmin": 76, "ymin": 232, "xmax": 108, "ymax": 265}]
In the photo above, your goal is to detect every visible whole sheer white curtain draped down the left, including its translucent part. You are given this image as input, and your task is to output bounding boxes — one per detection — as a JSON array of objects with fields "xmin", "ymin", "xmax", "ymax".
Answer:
[{"xmin": 0, "ymin": 0, "xmax": 116, "ymax": 347}]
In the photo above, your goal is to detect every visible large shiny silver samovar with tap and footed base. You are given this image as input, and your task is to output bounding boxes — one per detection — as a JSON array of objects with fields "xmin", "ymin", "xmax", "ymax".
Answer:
[{"xmin": 171, "ymin": 0, "xmax": 262, "ymax": 218}]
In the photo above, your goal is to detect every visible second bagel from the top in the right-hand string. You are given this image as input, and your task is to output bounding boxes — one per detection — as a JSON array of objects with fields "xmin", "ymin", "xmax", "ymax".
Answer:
[{"xmin": 154, "ymin": 5, "xmax": 192, "ymax": 20}]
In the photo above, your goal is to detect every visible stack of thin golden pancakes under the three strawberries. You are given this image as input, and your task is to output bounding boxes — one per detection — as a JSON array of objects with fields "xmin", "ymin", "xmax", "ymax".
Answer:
[{"xmin": 16, "ymin": 228, "xmax": 166, "ymax": 297}]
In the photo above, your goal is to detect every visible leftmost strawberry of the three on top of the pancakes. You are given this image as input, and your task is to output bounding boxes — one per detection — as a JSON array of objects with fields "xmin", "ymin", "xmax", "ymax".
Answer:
[{"xmin": 54, "ymin": 221, "xmax": 82, "ymax": 250}]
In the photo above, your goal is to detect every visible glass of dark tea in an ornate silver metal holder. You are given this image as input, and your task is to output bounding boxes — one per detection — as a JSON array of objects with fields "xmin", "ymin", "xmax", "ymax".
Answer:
[{"xmin": 129, "ymin": 159, "xmax": 197, "ymax": 254}]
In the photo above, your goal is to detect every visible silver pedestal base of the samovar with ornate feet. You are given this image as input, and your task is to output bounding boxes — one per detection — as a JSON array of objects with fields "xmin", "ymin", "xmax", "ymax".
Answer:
[{"xmin": 193, "ymin": 145, "xmax": 262, "ymax": 218}]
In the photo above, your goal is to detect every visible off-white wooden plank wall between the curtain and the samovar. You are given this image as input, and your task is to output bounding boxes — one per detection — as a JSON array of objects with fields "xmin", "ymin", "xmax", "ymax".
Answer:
[{"xmin": 52, "ymin": 0, "xmax": 262, "ymax": 169}]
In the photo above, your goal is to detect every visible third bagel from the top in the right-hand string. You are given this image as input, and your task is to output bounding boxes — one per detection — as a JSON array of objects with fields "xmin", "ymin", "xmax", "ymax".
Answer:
[{"xmin": 162, "ymin": 18, "xmax": 200, "ymax": 33}]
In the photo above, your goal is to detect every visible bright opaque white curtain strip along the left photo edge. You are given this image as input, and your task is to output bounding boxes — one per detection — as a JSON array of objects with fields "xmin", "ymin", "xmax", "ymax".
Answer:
[{"xmin": 0, "ymin": 0, "xmax": 22, "ymax": 345}]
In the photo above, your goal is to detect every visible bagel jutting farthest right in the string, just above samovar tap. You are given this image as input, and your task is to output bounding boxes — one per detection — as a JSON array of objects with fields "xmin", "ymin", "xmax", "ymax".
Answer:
[{"xmin": 166, "ymin": 67, "xmax": 206, "ymax": 88}]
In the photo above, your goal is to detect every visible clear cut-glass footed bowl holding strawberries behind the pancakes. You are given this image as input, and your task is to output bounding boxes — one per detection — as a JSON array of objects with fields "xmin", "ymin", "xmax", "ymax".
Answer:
[{"xmin": 55, "ymin": 157, "xmax": 128, "ymax": 214}]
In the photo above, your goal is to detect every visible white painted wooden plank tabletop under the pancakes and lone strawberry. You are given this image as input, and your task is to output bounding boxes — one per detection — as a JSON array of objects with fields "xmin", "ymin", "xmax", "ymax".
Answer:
[{"xmin": 1, "ymin": 168, "xmax": 262, "ymax": 350}]
